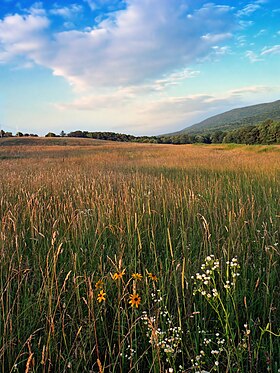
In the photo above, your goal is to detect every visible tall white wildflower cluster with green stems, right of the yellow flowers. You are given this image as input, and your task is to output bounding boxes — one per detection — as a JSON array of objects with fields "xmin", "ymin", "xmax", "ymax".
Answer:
[{"xmin": 192, "ymin": 255, "xmax": 242, "ymax": 371}]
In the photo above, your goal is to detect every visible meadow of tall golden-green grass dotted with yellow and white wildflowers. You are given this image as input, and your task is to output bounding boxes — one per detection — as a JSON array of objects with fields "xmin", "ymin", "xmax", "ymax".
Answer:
[{"xmin": 0, "ymin": 139, "xmax": 280, "ymax": 373}]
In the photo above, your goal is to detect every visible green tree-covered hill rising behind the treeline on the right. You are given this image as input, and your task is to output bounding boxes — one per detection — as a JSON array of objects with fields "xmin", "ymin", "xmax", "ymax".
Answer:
[{"xmin": 174, "ymin": 100, "xmax": 280, "ymax": 135}]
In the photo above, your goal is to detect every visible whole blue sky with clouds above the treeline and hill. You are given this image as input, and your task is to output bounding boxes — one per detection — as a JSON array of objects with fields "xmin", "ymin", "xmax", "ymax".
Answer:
[{"xmin": 0, "ymin": 0, "xmax": 280, "ymax": 135}]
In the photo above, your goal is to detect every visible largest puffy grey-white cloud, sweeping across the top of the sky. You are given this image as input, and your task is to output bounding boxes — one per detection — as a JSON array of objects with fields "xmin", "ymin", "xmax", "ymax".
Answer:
[{"xmin": 0, "ymin": 0, "xmax": 234, "ymax": 87}]
